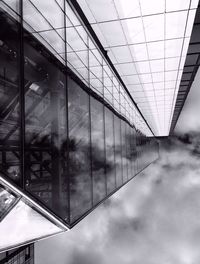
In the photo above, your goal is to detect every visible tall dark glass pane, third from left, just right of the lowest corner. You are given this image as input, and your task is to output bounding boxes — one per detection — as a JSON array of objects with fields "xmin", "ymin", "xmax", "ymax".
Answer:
[{"xmin": 68, "ymin": 78, "xmax": 92, "ymax": 222}]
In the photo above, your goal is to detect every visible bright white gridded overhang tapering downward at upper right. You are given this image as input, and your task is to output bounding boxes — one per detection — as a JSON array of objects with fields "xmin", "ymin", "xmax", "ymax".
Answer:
[{"xmin": 76, "ymin": 0, "xmax": 198, "ymax": 136}]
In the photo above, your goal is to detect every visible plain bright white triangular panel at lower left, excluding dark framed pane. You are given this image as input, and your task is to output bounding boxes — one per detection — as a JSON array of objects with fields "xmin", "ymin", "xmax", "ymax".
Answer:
[{"xmin": 0, "ymin": 200, "xmax": 63, "ymax": 250}]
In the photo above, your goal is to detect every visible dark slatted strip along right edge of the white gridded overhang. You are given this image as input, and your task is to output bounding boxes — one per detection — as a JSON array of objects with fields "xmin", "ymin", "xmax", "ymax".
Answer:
[{"xmin": 170, "ymin": 3, "xmax": 200, "ymax": 134}]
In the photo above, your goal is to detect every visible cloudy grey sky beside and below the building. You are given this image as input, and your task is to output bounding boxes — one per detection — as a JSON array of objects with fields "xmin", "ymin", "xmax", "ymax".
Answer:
[{"xmin": 36, "ymin": 68, "xmax": 200, "ymax": 264}]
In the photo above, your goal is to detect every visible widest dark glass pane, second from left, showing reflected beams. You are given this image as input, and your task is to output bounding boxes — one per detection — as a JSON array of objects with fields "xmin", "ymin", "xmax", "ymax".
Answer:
[{"xmin": 24, "ymin": 32, "xmax": 68, "ymax": 221}]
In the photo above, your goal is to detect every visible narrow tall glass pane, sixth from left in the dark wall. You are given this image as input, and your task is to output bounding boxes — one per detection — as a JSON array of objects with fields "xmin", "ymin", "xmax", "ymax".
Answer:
[{"xmin": 114, "ymin": 116, "xmax": 123, "ymax": 187}]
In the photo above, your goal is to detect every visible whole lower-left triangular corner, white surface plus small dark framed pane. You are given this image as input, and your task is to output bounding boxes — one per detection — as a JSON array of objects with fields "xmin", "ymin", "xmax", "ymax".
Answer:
[{"xmin": 0, "ymin": 176, "xmax": 65, "ymax": 251}]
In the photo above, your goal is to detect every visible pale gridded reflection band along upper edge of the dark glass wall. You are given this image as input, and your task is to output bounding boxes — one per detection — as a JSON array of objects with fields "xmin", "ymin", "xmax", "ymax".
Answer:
[{"xmin": 0, "ymin": 0, "xmax": 153, "ymax": 136}]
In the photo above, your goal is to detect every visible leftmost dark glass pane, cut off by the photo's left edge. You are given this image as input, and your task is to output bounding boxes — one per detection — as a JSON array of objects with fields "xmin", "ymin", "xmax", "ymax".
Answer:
[{"xmin": 0, "ymin": 4, "xmax": 21, "ymax": 184}]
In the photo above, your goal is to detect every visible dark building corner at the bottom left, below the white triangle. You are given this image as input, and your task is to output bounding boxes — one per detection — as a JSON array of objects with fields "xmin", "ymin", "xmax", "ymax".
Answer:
[{"xmin": 0, "ymin": 244, "xmax": 34, "ymax": 264}]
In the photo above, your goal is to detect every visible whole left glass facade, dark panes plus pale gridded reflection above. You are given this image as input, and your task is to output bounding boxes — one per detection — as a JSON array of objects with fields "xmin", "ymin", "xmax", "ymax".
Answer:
[{"xmin": 0, "ymin": 0, "xmax": 158, "ymax": 236}]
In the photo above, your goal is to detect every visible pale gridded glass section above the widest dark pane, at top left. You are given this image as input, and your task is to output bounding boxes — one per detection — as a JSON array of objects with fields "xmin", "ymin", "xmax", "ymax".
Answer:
[{"xmin": 23, "ymin": 0, "xmax": 65, "ymax": 58}]
